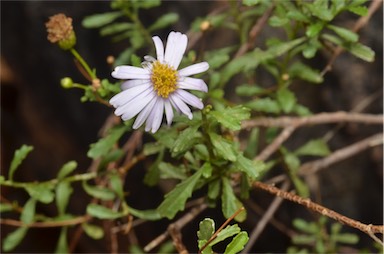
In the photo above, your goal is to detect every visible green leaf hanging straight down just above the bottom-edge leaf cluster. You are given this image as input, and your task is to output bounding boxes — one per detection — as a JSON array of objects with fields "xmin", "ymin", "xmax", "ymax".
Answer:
[{"xmin": 221, "ymin": 177, "xmax": 246, "ymax": 222}]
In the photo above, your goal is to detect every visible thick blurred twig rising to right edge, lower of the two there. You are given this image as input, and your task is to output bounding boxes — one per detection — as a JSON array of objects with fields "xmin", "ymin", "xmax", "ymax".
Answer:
[{"xmin": 299, "ymin": 133, "xmax": 383, "ymax": 175}]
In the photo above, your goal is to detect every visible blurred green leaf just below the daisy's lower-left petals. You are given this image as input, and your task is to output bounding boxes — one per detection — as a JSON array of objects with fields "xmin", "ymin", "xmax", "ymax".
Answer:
[{"xmin": 87, "ymin": 125, "xmax": 129, "ymax": 159}]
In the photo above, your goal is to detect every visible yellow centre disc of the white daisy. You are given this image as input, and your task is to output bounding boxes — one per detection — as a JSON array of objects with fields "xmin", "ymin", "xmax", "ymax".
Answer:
[{"xmin": 151, "ymin": 61, "xmax": 177, "ymax": 98}]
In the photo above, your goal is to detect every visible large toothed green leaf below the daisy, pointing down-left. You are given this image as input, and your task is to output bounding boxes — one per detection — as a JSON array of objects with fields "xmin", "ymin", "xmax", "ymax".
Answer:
[{"xmin": 157, "ymin": 170, "xmax": 203, "ymax": 219}]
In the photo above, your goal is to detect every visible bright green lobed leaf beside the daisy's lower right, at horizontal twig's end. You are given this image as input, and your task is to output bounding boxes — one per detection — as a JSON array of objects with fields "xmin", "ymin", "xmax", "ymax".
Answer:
[{"xmin": 210, "ymin": 105, "xmax": 251, "ymax": 130}]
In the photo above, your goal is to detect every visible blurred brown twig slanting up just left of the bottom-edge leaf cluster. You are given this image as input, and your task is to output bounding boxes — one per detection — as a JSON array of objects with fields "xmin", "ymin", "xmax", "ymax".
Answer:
[{"xmin": 144, "ymin": 203, "xmax": 208, "ymax": 252}]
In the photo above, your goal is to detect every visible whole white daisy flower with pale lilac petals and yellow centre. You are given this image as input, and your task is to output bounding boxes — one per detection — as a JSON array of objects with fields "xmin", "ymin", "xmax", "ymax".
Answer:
[{"xmin": 109, "ymin": 32, "xmax": 209, "ymax": 133}]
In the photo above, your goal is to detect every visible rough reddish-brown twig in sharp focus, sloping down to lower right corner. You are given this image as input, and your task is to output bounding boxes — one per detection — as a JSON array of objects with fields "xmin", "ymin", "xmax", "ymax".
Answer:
[{"xmin": 253, "ymin": 181, "xmax": 384, "ymax": 244}]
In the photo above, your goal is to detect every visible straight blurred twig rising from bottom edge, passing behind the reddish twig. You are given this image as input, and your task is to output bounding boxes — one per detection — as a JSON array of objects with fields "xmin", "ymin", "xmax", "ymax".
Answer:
[{"xmin": 243, "ymin": 180, "xmax": 289, "ymax": 253}]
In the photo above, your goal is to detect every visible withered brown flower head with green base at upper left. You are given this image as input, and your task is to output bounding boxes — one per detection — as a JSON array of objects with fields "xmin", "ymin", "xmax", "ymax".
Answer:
[{"xmin": 45, "ymin": 13, "xmax": 76, "ymax": 50}]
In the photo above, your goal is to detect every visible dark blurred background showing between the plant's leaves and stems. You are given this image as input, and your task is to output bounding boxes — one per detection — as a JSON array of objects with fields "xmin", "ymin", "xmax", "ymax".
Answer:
[{"xmin": 1, "ymin": 1, "xmax": 383, "ymax": 253}]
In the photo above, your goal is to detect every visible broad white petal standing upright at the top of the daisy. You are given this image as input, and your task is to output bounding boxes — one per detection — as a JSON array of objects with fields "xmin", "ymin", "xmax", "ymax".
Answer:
[{"xmin": 164, "ymin": 32, "xmax": 188, "ymax": 70}]
